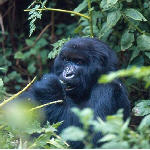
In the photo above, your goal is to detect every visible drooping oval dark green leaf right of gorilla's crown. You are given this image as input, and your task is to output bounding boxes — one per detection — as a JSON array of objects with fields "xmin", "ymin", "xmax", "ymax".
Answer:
[{"xmin": 121, "ymin": 30, "xmax": 134, "ymax": 50}]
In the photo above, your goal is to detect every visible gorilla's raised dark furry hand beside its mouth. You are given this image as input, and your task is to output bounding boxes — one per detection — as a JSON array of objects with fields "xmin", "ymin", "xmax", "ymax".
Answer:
[{"xmin": 32, "ymin": 74, "xmax": 65, "ymax": 103}]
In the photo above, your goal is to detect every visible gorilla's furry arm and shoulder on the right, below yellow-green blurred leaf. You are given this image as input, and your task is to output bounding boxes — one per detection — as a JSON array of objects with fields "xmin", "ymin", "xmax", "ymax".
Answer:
[{"xmin": 90, "ymin": 81, "xmax": 130, "ymax": 120}]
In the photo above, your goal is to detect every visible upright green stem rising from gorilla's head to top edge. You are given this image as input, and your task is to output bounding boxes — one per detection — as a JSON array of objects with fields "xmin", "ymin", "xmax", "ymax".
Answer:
[{"xmin": 87, "ymin": 0, "xmax": 94, "ymax": 37}]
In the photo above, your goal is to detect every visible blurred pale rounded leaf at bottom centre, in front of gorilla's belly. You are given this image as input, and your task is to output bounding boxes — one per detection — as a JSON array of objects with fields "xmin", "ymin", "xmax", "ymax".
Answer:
[{"xmin": 61, "ymin": 126, "xmax": 86, "ymax": 141}]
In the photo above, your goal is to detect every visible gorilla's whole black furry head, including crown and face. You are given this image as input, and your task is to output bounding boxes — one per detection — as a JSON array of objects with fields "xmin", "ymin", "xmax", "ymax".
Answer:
[{"xmin": 54, "ymin": 38, "xmax": 117, "ymax": 99}]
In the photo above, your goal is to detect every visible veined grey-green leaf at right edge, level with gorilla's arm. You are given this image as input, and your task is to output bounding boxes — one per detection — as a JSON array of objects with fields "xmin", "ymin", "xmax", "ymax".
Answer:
[{"xmin": 133, "ymin": 100, "xmax": 150, "ymax": 116}]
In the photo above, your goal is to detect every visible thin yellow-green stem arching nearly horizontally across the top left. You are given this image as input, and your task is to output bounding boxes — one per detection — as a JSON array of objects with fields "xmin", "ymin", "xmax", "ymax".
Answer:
[{"xmin": 24, "ymin": 8, "xmax": 90, "ymax": 20}]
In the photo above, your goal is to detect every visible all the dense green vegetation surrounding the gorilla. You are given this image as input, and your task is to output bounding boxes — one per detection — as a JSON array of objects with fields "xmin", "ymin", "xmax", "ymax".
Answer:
[{"xmin": 0, "ymin": 0, "xmax": 150, "ymax": 148}]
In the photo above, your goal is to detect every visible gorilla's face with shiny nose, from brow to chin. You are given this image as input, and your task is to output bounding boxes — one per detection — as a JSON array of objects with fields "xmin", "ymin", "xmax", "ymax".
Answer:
[{"xmin": 54, "ymin": 49, "xmax": 90, "ymax": 95}]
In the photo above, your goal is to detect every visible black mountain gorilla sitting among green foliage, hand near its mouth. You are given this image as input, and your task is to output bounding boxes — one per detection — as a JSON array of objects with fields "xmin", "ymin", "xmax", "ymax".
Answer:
[{"xmin": 19, "ymin": 38, "xmax": 130, "ymax": 148}]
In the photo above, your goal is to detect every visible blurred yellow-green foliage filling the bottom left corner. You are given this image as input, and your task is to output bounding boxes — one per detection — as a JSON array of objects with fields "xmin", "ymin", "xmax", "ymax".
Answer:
[{"xmin": 0, "ymin": 100, "xmax": 68, "ymax": 149}]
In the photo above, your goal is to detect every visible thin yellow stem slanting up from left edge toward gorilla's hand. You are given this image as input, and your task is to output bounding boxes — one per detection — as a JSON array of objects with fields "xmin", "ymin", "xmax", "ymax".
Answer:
[{"xmin": 0, "ymin": 77, "xmax": 36, "ymax": 108}]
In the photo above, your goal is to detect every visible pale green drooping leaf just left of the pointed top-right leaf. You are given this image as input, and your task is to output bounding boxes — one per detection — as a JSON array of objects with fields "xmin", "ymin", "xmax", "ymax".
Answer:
[{"xmin": 107, "ymin": 11, "xmax": 121, "ymax": 28}]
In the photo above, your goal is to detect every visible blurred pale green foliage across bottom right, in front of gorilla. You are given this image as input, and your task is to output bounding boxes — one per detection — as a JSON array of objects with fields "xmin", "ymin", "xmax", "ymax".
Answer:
[{"xmin": 62, "ymin": 108, "xmax": 150, "ymax": 149}]
